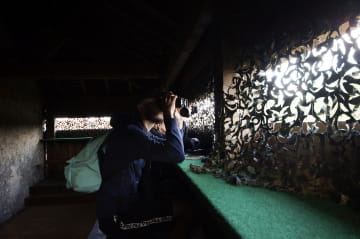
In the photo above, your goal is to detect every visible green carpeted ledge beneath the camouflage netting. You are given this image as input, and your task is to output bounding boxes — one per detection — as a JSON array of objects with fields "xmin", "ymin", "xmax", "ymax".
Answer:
[{"xmin": 179, "ymin": 159, "xmax": 360, "ymax": 239}]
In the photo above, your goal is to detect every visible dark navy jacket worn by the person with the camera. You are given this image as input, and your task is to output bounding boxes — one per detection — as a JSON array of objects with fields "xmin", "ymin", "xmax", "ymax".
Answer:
[{"xmin": 96, "ymin": 119, "xmax": 185, "ymax": 220}]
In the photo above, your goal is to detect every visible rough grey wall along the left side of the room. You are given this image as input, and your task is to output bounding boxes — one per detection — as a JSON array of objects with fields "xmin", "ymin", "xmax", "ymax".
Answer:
[{"xmin": 0, "ymin": 79, "xmax": 44, "ymax": 223}]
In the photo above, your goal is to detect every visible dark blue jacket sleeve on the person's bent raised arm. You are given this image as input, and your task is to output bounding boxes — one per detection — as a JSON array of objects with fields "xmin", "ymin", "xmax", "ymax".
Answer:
[{"xmin": 128, "ymin": 119, "xmax": 185, "ymax": 163}]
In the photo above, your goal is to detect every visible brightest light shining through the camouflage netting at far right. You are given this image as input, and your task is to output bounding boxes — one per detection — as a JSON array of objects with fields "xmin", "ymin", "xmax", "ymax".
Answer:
[{"xmin": 258, "ymin": 21, "xmax": 360, "ymax": 122}]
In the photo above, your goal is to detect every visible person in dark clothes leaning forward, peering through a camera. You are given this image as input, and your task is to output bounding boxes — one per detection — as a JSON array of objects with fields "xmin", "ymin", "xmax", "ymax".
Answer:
[{"xmin": 96, "ymin": 94, "xmax": 185, "ymax": 238}]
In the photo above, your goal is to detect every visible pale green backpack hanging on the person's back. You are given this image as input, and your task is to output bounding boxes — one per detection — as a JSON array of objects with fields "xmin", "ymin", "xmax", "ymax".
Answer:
[{"xmin": 64, "ymin": 133, "xmax": 109, "ymax": 193}]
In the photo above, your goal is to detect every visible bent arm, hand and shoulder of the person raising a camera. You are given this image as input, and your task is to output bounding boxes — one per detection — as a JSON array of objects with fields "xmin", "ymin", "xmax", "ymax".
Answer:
[{"xmin": 104, "ymin": 95, "xmax": 185, "ymax": 166}]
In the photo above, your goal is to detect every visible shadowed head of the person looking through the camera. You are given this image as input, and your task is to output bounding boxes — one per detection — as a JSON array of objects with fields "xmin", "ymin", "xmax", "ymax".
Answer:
[{"xmin": 139, "ymin": 99, "xmax": 164, "ymax": 124}]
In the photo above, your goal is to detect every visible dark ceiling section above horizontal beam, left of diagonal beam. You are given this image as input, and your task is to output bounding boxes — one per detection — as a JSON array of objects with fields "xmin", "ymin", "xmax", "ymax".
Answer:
[{"xmin": 1, "ymin": 0, "xmax": 207, "ymax": 68}]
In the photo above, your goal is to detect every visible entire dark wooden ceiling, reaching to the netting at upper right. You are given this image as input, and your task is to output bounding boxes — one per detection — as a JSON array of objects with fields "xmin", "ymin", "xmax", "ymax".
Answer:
[{"xmin": 0, "ymin": 0, "xmax": 354, "ymax": 115}]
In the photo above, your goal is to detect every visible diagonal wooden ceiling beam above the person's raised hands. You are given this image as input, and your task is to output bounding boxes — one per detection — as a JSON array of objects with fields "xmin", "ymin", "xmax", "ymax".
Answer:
[{"xmin": 162, "ymin": 1, "xmax": 212, "ymax": 90}]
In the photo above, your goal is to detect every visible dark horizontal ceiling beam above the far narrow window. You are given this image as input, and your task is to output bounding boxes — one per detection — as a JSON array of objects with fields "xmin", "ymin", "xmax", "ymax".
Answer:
[{"xmin": 0, "ymin": 63, "xmax": 160, "ymax": 80}]
